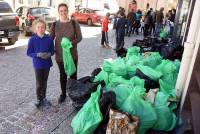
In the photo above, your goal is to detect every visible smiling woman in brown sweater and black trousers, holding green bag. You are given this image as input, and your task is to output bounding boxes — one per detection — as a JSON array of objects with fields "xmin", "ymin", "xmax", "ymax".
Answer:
[{"xmin": 50, "ymin": 3, "xmax": 82, "ymax": 103}]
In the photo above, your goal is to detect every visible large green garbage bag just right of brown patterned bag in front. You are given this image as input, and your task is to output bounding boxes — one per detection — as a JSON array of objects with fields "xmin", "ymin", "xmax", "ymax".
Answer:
[{"xmin": 120, "ymin": 87, "xmax": 157, "ymax": 134}]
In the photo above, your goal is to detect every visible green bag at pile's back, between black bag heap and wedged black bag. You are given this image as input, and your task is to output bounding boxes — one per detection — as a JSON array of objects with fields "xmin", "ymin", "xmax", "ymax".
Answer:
[{"xmin": 143, "ymin": 52, "xmax": 162, "ymax": 68}]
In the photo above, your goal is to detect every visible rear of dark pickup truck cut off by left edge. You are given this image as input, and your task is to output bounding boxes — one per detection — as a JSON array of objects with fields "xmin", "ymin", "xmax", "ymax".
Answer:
[{"xmin": 0, "ymin": 1, "xmax": 20, "ymax": 45}]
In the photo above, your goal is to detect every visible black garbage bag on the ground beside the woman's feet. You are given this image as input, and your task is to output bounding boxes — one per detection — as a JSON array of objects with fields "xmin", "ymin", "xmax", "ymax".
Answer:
[{"xmin": 67, "ymin": 77, "xmax": 98, "ymax": 103}]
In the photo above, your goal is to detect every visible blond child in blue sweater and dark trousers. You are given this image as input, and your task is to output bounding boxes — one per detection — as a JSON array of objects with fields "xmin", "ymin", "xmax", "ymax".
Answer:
[{"xmin": 27, "ymin": 19, "xmax": 54, "ymax": 108}]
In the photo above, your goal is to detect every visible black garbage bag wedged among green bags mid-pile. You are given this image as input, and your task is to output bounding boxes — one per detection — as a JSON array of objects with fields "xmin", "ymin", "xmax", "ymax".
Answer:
[{"xmin": 135, "ymin": 69, "xmax": 159, "ymax": 92}]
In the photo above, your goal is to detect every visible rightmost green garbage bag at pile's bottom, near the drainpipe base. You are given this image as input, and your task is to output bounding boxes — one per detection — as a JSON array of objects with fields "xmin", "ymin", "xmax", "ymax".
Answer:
[{"xmin": 153, "ymin": 92, "xmax": 177, "ymax": 131}]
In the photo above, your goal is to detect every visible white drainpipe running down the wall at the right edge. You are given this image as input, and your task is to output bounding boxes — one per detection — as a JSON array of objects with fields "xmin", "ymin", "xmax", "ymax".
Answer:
[{"xmin": 176, "ymin": 0, "xmax": 200, "ymax": 111}]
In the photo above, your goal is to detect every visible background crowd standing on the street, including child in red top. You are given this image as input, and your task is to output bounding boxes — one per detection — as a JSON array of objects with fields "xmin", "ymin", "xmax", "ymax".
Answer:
[{"xmin": 101, "ymin": 7, "xmax": 176, "ymax": 50}]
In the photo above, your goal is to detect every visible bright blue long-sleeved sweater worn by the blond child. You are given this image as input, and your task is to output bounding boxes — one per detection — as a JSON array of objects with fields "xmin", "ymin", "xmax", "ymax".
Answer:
[{"xmin": 27, "ymin": 34, "xmax": 54, "ymax": 69}]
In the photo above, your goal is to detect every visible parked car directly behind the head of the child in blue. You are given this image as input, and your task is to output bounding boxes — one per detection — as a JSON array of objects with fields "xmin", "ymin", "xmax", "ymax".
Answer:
[{"xmin": 16, "ymin": 6, "xmax": 56, "ymax": 35}]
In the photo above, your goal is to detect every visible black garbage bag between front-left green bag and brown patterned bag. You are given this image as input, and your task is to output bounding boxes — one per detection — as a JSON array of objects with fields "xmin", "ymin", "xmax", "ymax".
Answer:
[{"xmin": 94, "ymin": 91, "xmax": 116, "ymax": 134}]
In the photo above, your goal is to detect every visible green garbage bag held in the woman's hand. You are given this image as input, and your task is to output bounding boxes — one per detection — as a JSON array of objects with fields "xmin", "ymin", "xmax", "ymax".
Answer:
[{"xmin": 61, "ymin": 37, "xmax": 76, "ymax": 76}]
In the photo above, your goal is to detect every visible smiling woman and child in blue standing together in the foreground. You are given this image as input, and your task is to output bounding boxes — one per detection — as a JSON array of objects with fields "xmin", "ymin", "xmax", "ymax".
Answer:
[{"xmin": 27, "ymin": 3, "xmax": 82, "ymax": 108}]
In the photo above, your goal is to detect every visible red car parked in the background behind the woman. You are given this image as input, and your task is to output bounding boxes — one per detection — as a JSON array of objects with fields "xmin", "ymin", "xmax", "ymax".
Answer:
[{"xmin": 72, "ymin": 8, "xmax": 104, "ymax": 26}]
